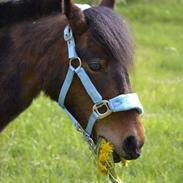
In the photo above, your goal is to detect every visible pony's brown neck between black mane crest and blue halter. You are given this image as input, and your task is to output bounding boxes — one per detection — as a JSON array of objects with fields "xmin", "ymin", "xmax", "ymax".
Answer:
[{"xmin": 0, "ymin": 15, "xmax": 67, "ymax": 131}]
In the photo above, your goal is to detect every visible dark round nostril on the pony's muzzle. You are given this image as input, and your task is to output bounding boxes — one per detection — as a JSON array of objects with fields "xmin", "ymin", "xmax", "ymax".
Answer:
[{"xmin": 123, "ymin": 136, "xmax": 140, "ymax": 159}]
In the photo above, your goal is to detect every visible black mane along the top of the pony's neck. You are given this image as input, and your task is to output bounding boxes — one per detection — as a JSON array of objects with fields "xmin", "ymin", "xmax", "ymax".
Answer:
[{"xmin": 0, "ymin": 0, "xmax": 61, "ymax": 28}]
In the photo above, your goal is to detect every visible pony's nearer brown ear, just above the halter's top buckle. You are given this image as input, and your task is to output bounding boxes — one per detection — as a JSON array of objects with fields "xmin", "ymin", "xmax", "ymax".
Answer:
[{"xmin": 62, "ymin": 0, "xmax": 87, "ymax": 35}]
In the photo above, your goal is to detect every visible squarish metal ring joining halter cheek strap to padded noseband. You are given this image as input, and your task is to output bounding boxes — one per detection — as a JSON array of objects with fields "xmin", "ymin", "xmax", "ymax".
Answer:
[{"xmin": 93, "ymin": 100, "xmax": 112, "ymax": 119}]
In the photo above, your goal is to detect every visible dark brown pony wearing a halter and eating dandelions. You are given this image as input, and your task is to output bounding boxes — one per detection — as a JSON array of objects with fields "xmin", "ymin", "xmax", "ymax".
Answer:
[{"xmin": 0, "ymin": 0, "xmax": 144, "ymax": 162}]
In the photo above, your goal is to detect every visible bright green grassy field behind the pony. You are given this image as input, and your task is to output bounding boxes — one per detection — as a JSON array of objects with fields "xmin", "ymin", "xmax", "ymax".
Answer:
[{"xmin": 0, "ymin": 0, "xmax": 183, "ymax": 183}]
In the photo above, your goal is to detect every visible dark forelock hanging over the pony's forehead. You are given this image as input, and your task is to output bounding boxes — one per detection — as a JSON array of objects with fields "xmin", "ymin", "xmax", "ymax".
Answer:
[{"xmin": 84, "ymin": 6, "xmax": 133, "ymax": 69}]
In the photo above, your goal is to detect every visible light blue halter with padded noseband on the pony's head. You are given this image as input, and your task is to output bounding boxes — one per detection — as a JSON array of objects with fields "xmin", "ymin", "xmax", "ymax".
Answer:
[{"xmin": 58, "ymin": 26, "xmax": 144, "ymax": 146}]
